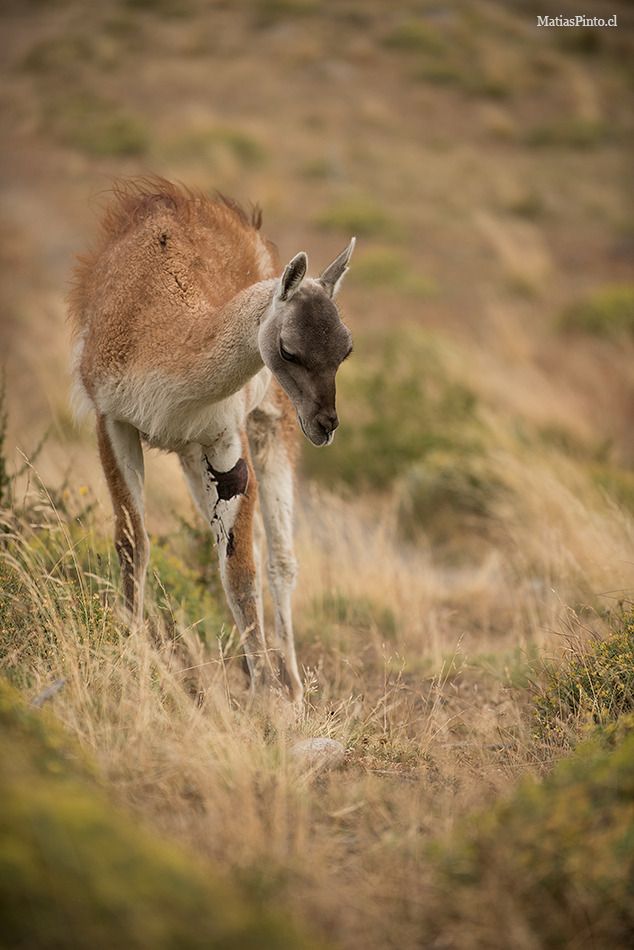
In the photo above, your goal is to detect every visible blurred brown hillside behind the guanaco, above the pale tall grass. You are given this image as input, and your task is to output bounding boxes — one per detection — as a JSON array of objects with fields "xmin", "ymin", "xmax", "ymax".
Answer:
[{"xmin": 0, "ymin": 0, "xmax": 634, "ymax": 518}]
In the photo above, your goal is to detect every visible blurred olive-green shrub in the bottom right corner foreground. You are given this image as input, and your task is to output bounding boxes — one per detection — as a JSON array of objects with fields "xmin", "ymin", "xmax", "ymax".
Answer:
[{"xmin": 423, "ymin": 717, "xmax": 634, "ymax": 950}]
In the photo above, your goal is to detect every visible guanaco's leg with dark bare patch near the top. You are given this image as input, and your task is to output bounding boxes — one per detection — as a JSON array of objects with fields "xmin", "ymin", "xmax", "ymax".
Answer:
[{"xmin": 180, "ymin": 436, "xmax": 271, "ymax": 687}]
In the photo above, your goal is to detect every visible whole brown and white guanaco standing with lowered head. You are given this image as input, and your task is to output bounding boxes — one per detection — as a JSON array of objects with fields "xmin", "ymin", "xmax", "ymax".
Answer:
[{"xmin": 70, "ymin": 178, "xmax": 355, "ymax": 701}]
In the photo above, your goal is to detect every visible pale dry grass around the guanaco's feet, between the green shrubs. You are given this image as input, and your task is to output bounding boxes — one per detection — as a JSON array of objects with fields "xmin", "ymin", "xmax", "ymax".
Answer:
[{"xmin": 2, "ymin": 448, "xmax": 634, "ymax": 947}]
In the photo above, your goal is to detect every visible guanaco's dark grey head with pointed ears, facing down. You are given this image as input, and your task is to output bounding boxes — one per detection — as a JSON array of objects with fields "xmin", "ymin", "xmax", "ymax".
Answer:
[{"xmin": 258, "ymin": 238, "xmax": 355, "ymax": 445}]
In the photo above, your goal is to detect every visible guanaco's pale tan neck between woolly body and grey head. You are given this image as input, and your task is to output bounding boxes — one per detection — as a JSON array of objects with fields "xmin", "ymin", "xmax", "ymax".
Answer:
[{"xmin": 190, "ymin": 280, "xmax": 276, "ymax": 401}]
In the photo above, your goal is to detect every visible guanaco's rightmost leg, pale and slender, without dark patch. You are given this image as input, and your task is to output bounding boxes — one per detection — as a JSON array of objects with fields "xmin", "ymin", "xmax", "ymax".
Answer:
[{"xmin": 249, "ymin": 410, "xmax": 304, "ymax": 702}]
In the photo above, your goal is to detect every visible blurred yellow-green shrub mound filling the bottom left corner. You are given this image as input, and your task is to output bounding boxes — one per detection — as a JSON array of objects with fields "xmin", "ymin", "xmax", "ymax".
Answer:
[{"xmin": 0, "ymin": 682, "xmax": 316, "ymax": 950}]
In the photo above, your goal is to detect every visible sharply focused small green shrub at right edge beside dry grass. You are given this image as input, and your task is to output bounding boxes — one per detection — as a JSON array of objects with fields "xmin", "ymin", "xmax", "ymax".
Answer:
[{"xmin": 535, "ymin": 614, "xmax": 634, "ymax": 744}]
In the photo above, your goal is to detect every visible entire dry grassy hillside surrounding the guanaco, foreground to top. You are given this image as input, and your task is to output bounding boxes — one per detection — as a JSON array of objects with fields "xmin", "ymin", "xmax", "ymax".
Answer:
[{"xmin": 0, "ymin": 0, "xmax": 634, "ymax": 950}]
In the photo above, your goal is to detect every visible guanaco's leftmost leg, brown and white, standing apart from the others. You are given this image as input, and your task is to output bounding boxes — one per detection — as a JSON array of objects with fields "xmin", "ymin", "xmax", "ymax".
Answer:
[{"xmin": 97, "ymin": 415, "xmax": 150, "ymax": 628}]
